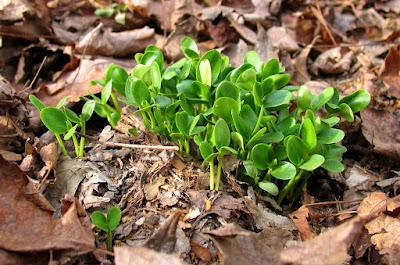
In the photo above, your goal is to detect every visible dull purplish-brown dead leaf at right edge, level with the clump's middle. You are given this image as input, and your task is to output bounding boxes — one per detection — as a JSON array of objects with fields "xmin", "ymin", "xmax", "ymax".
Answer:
[{"xmin": 361, "ymin": 108, "xmax": 400, "ymax": 160}]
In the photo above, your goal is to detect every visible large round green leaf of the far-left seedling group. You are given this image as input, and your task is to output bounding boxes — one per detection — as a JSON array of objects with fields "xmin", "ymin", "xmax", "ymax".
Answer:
[{"xmin": 40, "ymin": 107, "xmax": 68, "ymax": 134}]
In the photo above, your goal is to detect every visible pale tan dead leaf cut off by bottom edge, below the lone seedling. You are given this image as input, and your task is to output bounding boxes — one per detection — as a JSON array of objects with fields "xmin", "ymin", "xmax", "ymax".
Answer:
[{"xmin": 114, "ymin": 247, "xmax": 184, "ymax": 265}]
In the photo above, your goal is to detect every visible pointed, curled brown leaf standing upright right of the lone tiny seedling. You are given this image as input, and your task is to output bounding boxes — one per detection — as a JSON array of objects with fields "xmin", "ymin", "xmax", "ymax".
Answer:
[{"xmin": 144, "ymin": 212, "xmax": 182, "ymax": 253}]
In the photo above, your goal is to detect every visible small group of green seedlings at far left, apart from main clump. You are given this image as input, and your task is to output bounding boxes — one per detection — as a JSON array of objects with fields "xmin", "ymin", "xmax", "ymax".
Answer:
[{"xmin": 29, "ymin": 95, "xmax": 95, "ymax": 157}]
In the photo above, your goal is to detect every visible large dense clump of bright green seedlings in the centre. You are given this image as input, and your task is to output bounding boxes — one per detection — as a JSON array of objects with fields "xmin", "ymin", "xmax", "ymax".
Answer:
[{"xmin": 29, "ymin": 37, "xmax": 370, "ymax": 203}]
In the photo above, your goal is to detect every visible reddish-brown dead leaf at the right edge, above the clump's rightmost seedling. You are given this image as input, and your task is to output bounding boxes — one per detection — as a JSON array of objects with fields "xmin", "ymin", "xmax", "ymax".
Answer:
[{"xmin": 380, "ymin": 46, "xmax": 400, "ymax": 99}]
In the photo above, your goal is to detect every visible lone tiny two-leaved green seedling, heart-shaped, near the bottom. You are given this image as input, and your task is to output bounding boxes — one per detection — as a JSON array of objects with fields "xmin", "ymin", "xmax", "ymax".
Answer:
[{"xmin": 90, "ymin": 207, "xmax": 121, "ymax": 251}]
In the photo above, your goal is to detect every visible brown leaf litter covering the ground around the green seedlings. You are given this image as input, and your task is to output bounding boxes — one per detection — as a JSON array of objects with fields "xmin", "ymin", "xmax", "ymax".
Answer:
[{"xmin": 0, "ymin": 0, "xmax": 400, "ymax": 265}]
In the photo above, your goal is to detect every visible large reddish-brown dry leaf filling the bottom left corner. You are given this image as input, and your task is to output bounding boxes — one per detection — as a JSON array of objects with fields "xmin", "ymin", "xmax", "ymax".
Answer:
[{"xmin": 0, "ymin": 157, "xmax": 95, "ymax": 253}]
